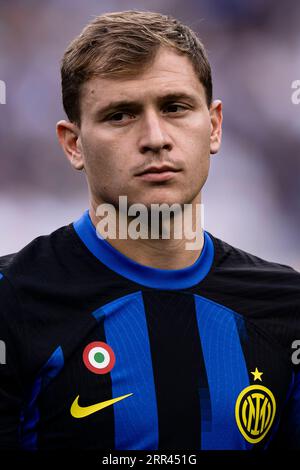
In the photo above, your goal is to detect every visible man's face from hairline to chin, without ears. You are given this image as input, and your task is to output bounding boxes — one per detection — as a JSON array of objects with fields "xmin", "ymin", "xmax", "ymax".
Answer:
[{"xmin": 71, "ymin": 48, "xmax": 221, "ymax": 207}]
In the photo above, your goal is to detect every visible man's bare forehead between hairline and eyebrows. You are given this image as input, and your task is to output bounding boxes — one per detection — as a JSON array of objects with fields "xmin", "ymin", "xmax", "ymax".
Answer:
[{"xmin": 81, "ymin": 48, "xmax": 205, "ymax": 111}]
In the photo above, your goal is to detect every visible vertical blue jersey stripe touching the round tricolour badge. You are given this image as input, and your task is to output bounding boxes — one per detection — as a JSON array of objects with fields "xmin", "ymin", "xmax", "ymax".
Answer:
[{"xmin": 93, "ymin": 292, "xmax": 158, "ymax": 450}]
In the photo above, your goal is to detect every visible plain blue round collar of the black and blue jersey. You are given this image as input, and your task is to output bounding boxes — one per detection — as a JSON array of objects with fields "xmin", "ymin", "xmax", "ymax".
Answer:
[{"xmin": 73, "ymin": 210, "xmax": 214, "ymax": 290}]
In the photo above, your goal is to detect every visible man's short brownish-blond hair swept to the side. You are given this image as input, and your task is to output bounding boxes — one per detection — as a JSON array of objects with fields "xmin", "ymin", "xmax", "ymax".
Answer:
[{"xmin": 61, "ymin": 10, "xmax": 212, "ymax": 125}]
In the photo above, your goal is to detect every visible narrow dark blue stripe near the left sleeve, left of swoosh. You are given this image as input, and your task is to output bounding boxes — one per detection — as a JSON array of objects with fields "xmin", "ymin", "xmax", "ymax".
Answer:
[{"xmin": 20, "ymin": 346, "xmax": 64, "ymax": 450}]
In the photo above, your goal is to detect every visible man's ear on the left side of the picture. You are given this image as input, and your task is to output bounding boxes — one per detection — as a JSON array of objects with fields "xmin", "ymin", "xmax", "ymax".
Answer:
[{"xmin": 56, "ymin": 120, "xmax": 84, "ymax": 170}]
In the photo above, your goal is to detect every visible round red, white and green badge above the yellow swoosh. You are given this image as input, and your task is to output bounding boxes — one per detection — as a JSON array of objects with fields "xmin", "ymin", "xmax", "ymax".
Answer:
[{"xmin": 83, "ymin": 341, "xmax": 116, "ymax": 374}]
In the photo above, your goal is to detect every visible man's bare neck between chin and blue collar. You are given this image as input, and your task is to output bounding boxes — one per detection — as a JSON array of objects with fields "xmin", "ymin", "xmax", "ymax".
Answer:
[{"xmin": 89, "ymin": 195, "xmax": 204, "ymax": 270}]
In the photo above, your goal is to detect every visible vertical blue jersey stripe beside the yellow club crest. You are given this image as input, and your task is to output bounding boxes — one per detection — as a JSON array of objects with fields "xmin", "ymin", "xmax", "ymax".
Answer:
[{"xmin": 195, "ymin": 295, "xmax": 252, "ymax": 450}]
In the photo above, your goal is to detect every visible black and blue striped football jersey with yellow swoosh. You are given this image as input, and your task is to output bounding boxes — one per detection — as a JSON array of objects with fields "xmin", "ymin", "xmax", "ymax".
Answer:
[{"xmin": 0, "ymin": 211, "xmax": 300, "ymax": 451}]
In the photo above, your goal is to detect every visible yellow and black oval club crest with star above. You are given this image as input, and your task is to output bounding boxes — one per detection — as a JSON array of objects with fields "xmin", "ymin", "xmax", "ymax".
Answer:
[{"xmin": 235, "ymin": 368, "xmax": 276, "ymax": 444}]
